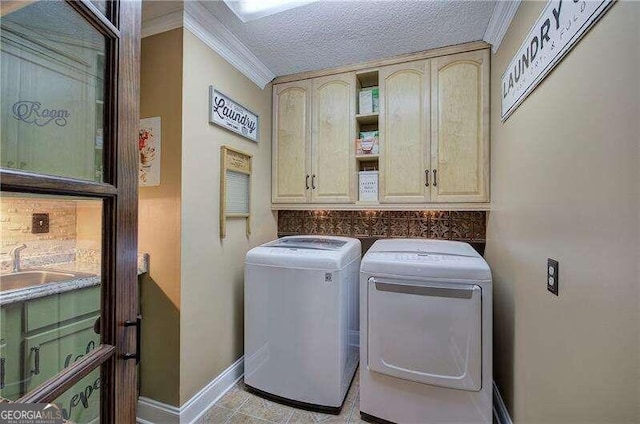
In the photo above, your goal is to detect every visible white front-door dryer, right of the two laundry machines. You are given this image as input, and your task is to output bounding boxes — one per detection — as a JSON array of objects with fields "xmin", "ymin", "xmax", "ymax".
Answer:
[{"xmin": 360, "ymin": 239, "xmax": 492, "ymax": 424}]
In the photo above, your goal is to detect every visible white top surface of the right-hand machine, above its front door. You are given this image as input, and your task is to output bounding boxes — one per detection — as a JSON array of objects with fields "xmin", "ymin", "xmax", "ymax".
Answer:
[{"xmin": 361, "ymin": 239, "xmax": 491, "ymax": 281}]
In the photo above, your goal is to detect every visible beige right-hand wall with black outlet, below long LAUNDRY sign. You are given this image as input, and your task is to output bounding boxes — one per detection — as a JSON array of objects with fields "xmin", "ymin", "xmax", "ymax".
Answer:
[{"xmin": 486, "ymin": 2, "xmax": 640, "ymax": 423}]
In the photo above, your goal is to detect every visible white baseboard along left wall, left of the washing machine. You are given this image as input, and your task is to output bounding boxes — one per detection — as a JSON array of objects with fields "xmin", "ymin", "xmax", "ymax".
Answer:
[{"xmin": 136, "ymin": 356, "xmax": 244, "ymax": 424}]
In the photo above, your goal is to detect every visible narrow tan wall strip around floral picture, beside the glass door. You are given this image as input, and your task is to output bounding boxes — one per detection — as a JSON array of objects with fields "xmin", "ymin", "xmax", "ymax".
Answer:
[{"xmin": 138, "ymin": 29, "xmax": 182, "ymax": 406}]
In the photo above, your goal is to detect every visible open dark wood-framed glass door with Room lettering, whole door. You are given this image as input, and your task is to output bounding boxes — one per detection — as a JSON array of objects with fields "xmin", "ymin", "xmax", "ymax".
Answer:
[{"xmin": 0, "ymin": 0, "xmax": 141, "ymax": 423}]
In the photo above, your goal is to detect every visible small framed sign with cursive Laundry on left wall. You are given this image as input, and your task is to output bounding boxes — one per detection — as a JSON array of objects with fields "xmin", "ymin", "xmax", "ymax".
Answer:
[{"xmin": 209, "ymin": 86, "xmax": 259, "ymax": 143}]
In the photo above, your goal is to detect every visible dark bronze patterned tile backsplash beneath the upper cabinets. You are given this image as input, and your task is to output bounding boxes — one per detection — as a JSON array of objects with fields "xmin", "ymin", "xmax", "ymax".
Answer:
[{"xmin": 278, "ymin": 210, "xmax": 487, "ymax": 243}]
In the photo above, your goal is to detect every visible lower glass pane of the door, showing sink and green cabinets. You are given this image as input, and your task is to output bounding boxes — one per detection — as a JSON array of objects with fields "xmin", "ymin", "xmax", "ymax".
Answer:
[{"xmin": 0, "ymin": 192, "xmax": 103, "ymax": 400}]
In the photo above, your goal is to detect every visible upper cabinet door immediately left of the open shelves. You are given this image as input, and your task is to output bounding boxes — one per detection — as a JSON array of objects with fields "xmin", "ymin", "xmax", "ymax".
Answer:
[{"xmin": 311, "ymin": 73, "xmax": 356, "ymax": 203}]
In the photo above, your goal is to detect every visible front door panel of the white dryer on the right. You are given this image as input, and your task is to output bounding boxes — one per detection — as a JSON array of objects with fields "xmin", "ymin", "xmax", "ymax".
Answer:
[{"xmin": 367, "ymin": 277, "xmax": 482, "ymax": 391}]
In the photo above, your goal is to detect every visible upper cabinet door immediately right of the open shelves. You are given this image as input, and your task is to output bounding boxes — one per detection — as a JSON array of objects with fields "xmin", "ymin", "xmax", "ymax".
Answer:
[{"xmin": 380, "ymin": 61, "xmax": 429, "ymax": 203}]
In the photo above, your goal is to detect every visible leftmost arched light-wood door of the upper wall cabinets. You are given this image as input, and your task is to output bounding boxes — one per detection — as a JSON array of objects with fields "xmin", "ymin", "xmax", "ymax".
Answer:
[{"xmin": 271, "ymin": 80, "xmax": 311, "ymax": 203}]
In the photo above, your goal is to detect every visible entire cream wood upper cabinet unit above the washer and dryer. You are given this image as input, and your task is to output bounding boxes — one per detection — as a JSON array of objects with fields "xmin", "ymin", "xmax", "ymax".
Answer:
[{"xmin": 272, "ymin": 43, "xmax": 490, "ymax": 210}]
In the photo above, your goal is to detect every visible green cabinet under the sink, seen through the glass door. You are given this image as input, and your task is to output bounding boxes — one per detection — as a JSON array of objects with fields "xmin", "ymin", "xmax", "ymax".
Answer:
[{"xmin": 0, "ymin": 286, "xmax": 100, "ymax": 423}]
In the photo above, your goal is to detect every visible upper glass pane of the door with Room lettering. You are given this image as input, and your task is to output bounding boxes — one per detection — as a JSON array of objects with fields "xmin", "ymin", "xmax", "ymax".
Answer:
[{"xmin": 0, "ymin": 1, "xmax": 108, "ymax": 182}]
